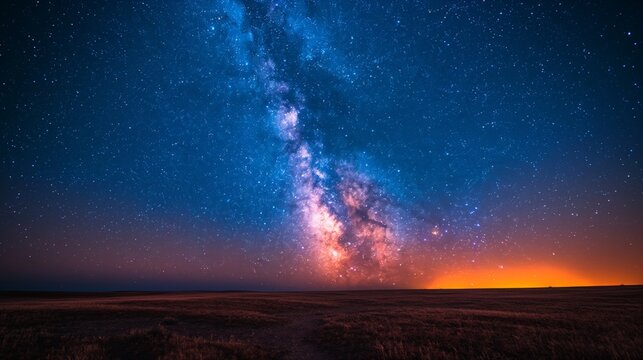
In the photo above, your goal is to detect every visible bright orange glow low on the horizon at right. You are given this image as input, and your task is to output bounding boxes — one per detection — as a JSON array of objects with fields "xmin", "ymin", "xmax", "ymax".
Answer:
[{"xmin": 427, "ymin": 265, "xmax": 608, "ymax": 289}]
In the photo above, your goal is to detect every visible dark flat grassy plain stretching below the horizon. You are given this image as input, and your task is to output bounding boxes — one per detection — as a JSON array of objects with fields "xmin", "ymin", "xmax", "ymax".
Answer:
[{"xmin": 0, "ymin": 286, "xmax": 643, "ymax": 359}]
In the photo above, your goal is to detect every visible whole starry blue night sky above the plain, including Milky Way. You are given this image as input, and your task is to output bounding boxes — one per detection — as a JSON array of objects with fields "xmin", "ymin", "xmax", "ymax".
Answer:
[{"xmin": 0, "ymin": 0, "xmax": 643, "ymax": 290}]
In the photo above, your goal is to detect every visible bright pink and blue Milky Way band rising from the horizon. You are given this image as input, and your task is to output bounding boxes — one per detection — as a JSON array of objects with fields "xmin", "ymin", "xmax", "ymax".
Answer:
[{"xmin": 247, "ymin": 4, "xmax": 401, "ymax": 283}]
